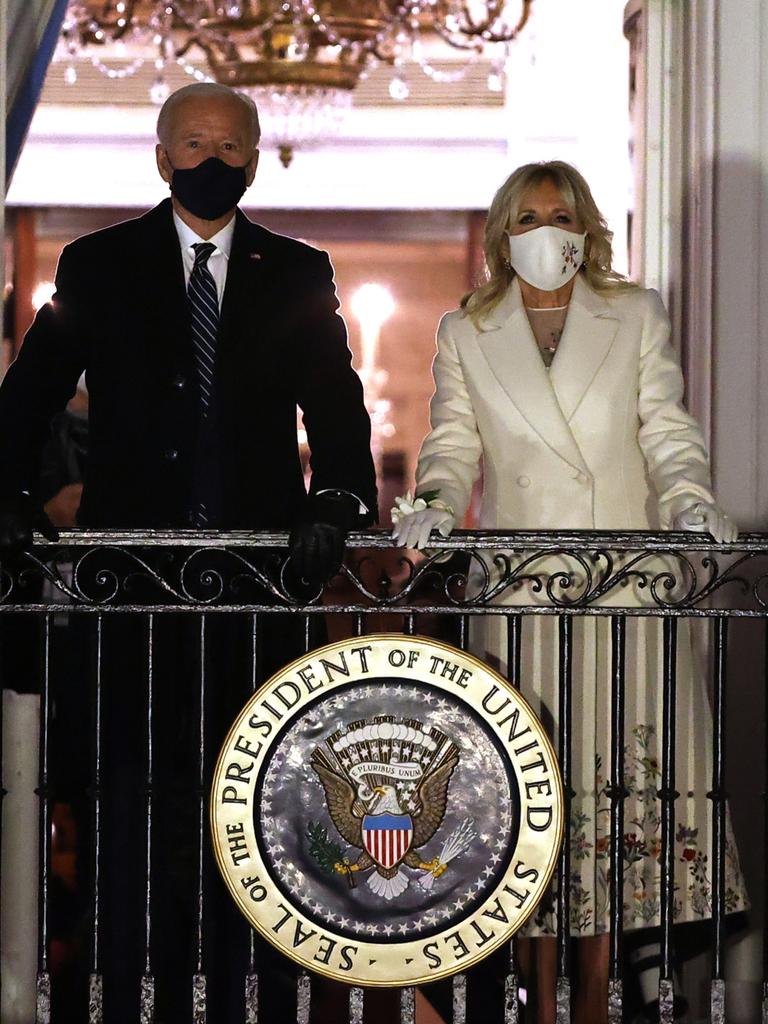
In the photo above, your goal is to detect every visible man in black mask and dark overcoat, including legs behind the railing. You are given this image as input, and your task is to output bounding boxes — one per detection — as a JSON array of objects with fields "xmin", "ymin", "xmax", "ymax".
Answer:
[{"xmin": 0, "ymin": 84, "xmax": 376, "ymax": 1024}]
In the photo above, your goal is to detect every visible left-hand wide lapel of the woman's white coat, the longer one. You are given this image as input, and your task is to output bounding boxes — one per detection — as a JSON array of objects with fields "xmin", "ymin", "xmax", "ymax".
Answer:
[{"xmin": 477, "ymin": 279, "xmax": 587, "ymax": 470}]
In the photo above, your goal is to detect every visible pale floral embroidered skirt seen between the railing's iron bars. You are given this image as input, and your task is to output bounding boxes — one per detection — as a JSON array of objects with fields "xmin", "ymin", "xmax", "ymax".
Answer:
[{"xmin": 471, "ymin": 615, "xmax": 748, "ymax": 936}]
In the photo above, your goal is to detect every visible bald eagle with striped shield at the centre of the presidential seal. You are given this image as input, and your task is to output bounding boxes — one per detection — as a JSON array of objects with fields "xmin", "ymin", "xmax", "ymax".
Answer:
[{"xmin": 310, "ymin": 716, "xmax": 476, "ymax": 900}]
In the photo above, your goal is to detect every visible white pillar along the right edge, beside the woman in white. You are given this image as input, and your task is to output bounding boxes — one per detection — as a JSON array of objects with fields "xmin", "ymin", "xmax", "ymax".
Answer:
[{"xmin": 634, "ymin": 0, "xmax": 768, "ymax": 1024}]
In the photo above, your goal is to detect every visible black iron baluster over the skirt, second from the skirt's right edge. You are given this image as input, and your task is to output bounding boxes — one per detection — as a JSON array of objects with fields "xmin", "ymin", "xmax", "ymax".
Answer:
[{"xmin": 658, "ymin": 615, "xmax": 678, "ymax": 1024}]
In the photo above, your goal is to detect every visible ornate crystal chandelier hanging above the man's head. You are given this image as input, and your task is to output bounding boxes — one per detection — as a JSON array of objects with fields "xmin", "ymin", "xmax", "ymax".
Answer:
[{"xmin": 58, "ymin": 0, "xmax": 532, "ymax": 166}]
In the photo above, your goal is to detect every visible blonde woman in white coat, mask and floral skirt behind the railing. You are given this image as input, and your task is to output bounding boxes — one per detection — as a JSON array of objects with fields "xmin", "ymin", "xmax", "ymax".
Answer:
[{"xmin": 393, "ymin": 162, "xmax": 744, "ymax": 1024}]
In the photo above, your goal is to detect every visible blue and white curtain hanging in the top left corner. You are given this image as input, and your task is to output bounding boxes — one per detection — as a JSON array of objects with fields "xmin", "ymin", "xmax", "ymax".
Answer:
[{"xmin": 5, "ymin": 0, "xmax": 68, "ymax": 186}]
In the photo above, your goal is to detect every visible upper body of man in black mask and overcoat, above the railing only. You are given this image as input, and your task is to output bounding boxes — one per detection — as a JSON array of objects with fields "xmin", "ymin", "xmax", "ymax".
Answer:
[{"xmin": 0, "ymin": 84, "xmax": 376, "ymax": 531}]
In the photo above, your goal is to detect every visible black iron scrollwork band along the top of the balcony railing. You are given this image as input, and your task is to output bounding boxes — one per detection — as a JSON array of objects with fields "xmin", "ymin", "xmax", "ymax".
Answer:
[{"xmin": 0, "ymin": 530, "xmax": 768, "ymax": 615}]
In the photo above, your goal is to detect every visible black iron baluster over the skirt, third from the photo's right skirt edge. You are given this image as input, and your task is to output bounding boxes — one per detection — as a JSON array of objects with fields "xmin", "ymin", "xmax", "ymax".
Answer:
[{"xmin": 608, "ymin": 615, "xmax": 627, "ymax": 1024}]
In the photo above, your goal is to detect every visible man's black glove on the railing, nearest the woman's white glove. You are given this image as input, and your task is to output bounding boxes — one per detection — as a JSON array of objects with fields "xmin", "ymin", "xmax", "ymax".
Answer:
[{"xmin": 288, "ymin": 490, "xmax": 359, "ymax": 587}]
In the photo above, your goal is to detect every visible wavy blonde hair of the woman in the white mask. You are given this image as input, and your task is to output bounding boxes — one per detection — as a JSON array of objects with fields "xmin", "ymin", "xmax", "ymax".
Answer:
[{"xmin": 461, "ymin": 160, "xmax": 637, "ymax": 325}]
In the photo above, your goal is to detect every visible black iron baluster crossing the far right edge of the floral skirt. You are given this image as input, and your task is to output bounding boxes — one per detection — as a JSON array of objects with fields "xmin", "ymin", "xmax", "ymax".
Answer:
[{"xmin": 709, "ymin": 616, "xmax": 728, "ymax": 1024}]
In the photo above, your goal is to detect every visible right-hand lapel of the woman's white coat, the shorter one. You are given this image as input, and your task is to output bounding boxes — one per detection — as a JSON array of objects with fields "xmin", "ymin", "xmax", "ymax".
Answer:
[{"xmin": 550, "ymin": 275, "xmax": 618, "ymax": 422}]
